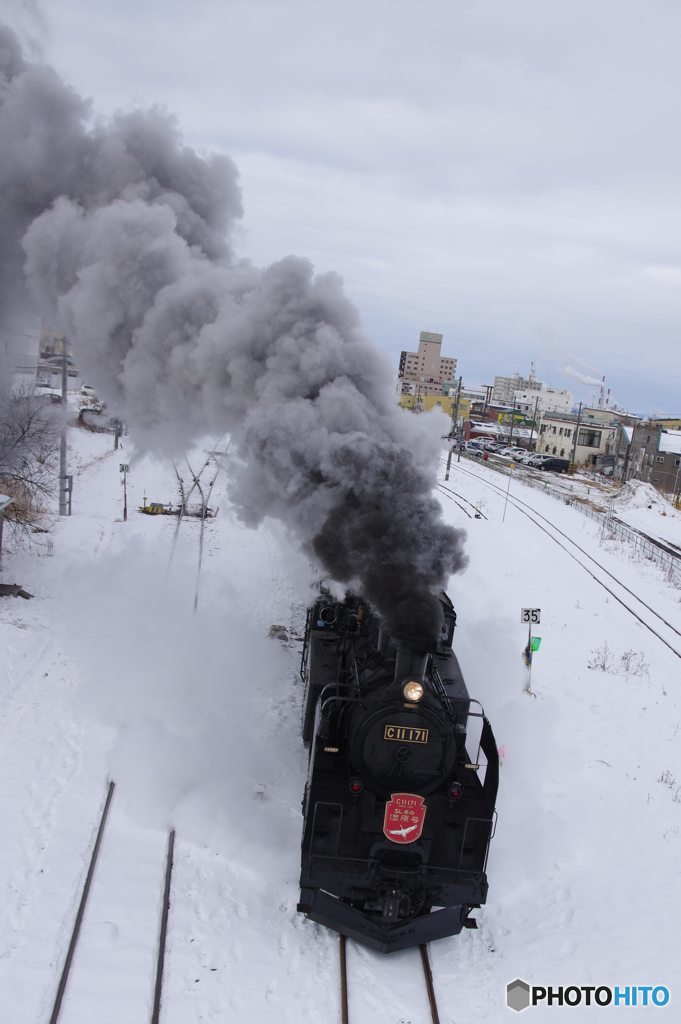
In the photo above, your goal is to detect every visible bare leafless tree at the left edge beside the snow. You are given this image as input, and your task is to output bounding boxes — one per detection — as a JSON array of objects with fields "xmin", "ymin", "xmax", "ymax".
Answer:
[{"xmin": 0, "ymin": 388, "xmax": 60, "ymax": 538}]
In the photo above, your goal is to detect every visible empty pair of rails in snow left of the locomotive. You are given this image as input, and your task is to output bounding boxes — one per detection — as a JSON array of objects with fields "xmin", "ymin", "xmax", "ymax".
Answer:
[{"xmin": 49, "ymin": 781, "xmax": 175, "ymax": 1024}]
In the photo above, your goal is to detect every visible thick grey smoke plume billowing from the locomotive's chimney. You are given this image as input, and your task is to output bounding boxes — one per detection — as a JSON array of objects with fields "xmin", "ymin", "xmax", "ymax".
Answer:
[{"xmin": 0, "ymin": 24, "xmax": 464, "ymax": 635}]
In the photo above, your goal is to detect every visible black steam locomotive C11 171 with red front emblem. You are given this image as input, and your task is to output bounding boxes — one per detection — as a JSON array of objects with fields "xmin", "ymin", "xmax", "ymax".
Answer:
[{"xmin": 298, "ymin": 593, "xmax": 499, "ymax": 952}]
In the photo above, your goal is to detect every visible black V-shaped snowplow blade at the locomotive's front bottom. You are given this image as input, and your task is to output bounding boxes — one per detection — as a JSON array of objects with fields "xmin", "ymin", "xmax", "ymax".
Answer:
[{"xmin": 298, "ymin": 889, "xmax": 470, "ymax": 953}]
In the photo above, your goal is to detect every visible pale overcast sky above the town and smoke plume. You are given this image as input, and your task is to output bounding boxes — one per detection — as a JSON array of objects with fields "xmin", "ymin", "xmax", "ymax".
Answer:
[{"xmin": 5, "ymin": 0, "xmax": 681, "ymax": 415}]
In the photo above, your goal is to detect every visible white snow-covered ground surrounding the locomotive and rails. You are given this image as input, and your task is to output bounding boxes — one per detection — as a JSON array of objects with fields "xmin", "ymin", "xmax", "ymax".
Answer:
[{"xmin": 0, "ymin": 430, "xmax": 681, "ymax": 1024}]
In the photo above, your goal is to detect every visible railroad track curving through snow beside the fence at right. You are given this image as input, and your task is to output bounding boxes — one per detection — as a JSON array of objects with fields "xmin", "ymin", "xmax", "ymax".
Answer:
[{"xmin": 438, "ymin": 460, "xmax": 681, "ymax": 658}]
